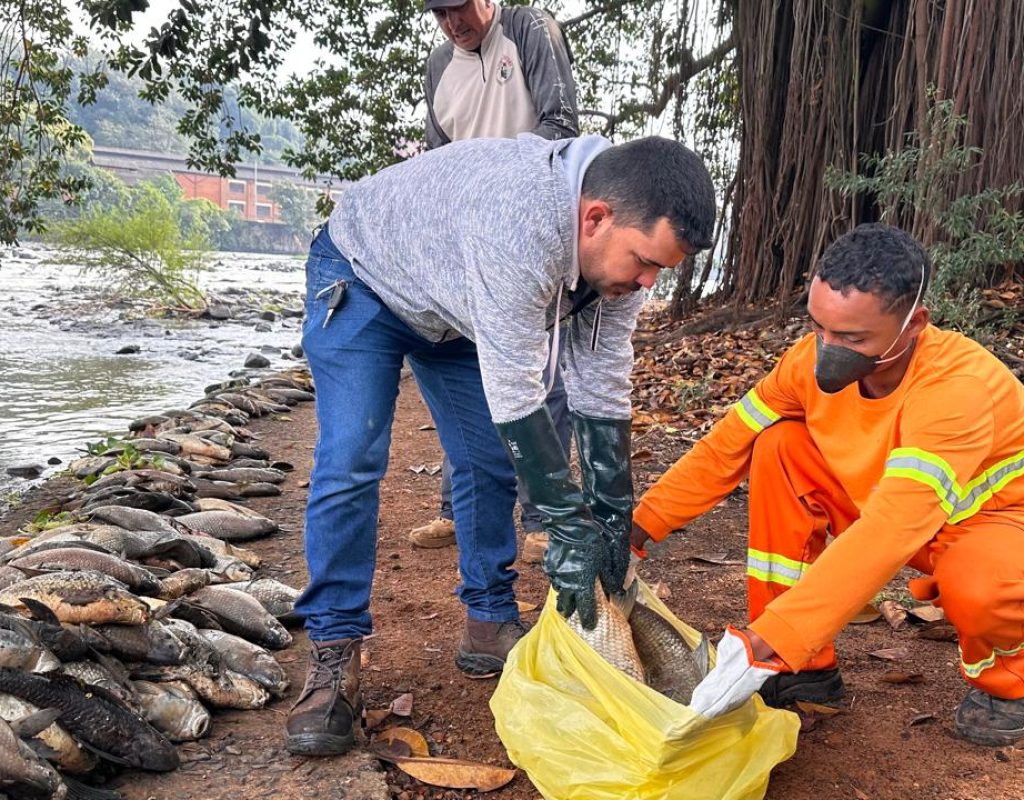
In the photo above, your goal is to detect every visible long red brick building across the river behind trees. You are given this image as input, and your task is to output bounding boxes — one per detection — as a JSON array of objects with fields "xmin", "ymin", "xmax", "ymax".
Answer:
[{"xmin": 92, "ymin": 145, "xmax": 341, "ymax": 222}]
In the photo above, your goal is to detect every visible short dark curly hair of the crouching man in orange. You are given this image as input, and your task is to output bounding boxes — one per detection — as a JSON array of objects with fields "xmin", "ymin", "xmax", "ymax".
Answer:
[{"xmin": 818, "ymin": 222, "xmax": 931, "ymax": 313}]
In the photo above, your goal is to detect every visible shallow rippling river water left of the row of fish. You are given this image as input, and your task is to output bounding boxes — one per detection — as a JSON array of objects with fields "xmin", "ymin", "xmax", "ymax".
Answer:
[{"xmin": 0, "ymin": 243, "xmax": 304, "ymax": 495}]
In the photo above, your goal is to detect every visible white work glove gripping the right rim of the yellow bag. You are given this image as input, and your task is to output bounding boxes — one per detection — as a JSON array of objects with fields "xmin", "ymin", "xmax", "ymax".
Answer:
[{"xmin": 690, "ymin": 625, "xmax": 785, "ymax": 717}]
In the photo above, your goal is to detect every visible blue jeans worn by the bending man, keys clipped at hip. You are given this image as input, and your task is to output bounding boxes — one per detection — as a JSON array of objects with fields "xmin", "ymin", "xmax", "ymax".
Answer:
[{"xmin": 296, "ymin": 228, "xmax": 519, "ymax": 641}]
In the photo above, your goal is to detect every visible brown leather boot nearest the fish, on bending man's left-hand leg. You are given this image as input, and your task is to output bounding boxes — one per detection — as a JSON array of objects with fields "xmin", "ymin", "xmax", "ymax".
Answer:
[{"xmin": 285, "ymin": 639, "xmax": 362, "ymax": 756}]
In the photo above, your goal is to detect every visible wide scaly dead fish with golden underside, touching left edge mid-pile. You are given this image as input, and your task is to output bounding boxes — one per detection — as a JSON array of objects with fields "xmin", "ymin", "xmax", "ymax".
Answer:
[{"xmin": 0, "ymin": 571, "xmax": 150, "ymax": 625}]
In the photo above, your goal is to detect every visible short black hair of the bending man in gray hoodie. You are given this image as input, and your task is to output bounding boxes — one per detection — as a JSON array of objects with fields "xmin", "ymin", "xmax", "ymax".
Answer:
[{"xmin": 583, "ymin": 136, "xmax": 715, "ymax": 250}]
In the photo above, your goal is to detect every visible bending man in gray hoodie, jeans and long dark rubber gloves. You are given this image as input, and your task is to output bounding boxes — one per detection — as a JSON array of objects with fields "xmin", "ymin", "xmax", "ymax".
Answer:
[{"xmin": 287, "ymin": 134, "xmax": 715, "ymax": 755}]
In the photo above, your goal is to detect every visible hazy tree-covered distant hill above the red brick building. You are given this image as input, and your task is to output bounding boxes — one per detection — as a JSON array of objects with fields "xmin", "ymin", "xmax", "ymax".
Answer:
[{"xmin": 70, "ymin": 56, "xmax": 302, "ymax": 164}]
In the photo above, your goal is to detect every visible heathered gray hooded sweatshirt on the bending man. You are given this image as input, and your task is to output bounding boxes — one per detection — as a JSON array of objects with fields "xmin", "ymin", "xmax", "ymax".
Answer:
[{"xmin": 329, "ymin": 134, "xmax": 642, "ymax": 423}]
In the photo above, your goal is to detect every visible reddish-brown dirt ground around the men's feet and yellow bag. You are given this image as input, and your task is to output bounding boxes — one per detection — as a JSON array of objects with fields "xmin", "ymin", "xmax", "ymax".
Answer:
[{"xmin": 3, "ymin": 380, "xmax": 1024, "ymax": 800}]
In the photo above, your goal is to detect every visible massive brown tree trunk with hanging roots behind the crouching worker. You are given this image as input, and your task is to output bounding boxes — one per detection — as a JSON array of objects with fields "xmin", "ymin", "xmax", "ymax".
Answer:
[{"xmin": 724, "ymin": 0, "xmax": 1024, "ymax": 303}]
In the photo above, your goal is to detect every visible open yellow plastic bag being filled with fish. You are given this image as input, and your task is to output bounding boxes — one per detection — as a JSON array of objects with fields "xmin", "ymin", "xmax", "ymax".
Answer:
[{"xmin": 490, "ymin": 583, "xmax": 800, "ymax": 800}]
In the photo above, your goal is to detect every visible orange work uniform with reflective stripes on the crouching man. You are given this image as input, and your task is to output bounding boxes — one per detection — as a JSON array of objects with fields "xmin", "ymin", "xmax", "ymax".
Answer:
[{"xmin": 633, "ymin": 326, "xmax": 1024, "ymax": 699}]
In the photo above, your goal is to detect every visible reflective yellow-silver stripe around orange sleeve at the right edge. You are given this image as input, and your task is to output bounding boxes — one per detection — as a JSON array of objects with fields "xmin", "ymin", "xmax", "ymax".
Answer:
[{"xmin": 883, "ymin": 448, "xmax": 1024, "ymax": 523}]
